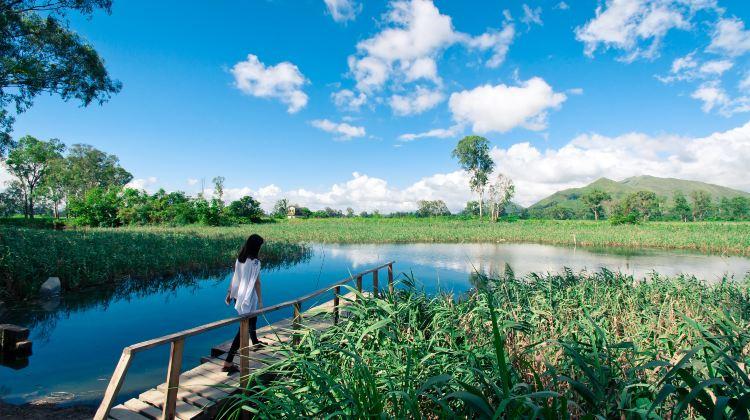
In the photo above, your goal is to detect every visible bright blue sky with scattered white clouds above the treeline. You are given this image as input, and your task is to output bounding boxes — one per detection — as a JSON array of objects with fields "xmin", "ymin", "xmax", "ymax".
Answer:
[{"xmin": 4, "ymin": 0, "xmax": 750, "ymax": 211}]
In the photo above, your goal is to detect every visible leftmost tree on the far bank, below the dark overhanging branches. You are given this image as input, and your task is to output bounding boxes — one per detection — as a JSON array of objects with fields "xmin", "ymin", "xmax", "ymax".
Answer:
[{"xmin": 5, "ymin": 136, "xmax": 65, "ymax": 219}]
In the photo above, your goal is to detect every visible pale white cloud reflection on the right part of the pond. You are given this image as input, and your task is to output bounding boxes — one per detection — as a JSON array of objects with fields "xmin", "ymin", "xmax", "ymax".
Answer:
[{"xmin": 322, "ymin": 244, "xmax": 750, "ymax": 280}]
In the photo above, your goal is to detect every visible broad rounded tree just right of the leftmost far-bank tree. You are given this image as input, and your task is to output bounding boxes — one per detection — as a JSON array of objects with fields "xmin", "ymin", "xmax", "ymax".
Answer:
[{"xmin": 61, "ymin": 144, "xmax": 133, "ymax": 198}]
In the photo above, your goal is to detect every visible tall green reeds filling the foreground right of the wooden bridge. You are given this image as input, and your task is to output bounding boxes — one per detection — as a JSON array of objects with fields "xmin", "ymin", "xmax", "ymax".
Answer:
[{"xmin": 224, "ymin": 269, "xmax": 750, "ymax": 419}]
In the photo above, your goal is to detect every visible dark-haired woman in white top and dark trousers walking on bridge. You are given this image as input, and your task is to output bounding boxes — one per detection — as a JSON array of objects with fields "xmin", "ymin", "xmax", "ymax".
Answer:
[{"xmin": 222, "ymin": 234, "xmax": 263, "ymax": 375}]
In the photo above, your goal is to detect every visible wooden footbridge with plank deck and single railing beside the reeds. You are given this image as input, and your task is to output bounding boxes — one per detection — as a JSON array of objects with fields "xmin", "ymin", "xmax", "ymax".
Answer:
[{"xmin": 94, "ymin": 261, "xmax": 394, "ymax": 420}]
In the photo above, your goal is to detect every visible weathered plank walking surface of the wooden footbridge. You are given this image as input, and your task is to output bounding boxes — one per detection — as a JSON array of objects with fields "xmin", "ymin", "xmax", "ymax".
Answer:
[{"xmin": 109, "ymin": 293, "xmax": 362, "ymax": 420}]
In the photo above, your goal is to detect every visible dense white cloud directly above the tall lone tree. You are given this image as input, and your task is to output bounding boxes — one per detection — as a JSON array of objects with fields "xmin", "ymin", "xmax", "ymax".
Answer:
[{"xmin": 449, "ymin": 77, "xmax": 567, "ymax": 133}]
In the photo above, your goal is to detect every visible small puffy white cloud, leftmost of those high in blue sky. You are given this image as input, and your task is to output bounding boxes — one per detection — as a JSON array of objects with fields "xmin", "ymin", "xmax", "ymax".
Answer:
[{"xmin": 231, "ymin": 54, "xmax": 308, "ymax": 114}]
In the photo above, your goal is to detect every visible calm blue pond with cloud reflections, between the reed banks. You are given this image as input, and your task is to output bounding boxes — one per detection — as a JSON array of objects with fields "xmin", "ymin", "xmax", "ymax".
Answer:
[{"xmin": 0, "ymin": 244, "xmax": 750, "ymax": 405}]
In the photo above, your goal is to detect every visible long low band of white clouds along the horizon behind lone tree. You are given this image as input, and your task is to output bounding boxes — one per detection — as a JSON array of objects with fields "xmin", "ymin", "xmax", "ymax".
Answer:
[{"xmin": 220, "ymin": 123, "xmax": 750, "ymax": 212}]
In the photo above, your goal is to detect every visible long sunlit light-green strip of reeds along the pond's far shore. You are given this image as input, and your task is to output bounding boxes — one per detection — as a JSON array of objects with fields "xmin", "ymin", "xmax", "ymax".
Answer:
[{"xmin": 129, "ymin": 218, "xmax": 750, "ymax": 255}]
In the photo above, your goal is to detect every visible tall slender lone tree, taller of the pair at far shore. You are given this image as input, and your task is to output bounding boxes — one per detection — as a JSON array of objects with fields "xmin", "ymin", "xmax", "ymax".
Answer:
[{"xmin": 452, "ymin": 136, "xmax": 495, "ymax": 219}]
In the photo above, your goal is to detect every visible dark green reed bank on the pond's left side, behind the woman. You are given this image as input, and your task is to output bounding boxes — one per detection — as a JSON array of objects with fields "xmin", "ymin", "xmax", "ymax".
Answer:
[{"xmin": 0, "ymin": 227, "xmax": 309, "ymax": 299}]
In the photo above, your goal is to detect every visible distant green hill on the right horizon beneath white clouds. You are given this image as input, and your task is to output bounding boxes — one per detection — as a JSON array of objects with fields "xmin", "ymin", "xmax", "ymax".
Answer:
[{"xmin": 529, "ymin": 175, "xmax": 750, "ymax": 214}]
